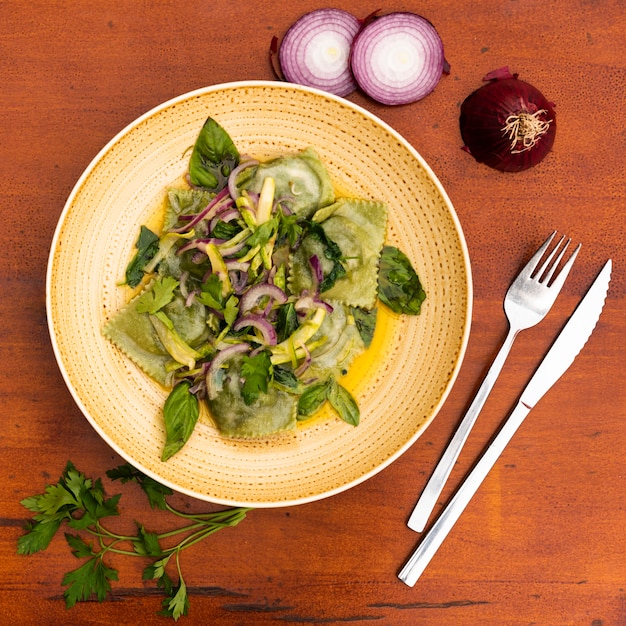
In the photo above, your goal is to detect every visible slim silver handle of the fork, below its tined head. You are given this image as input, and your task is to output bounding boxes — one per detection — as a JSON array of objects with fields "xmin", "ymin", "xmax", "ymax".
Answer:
[{"xmin": 407, "ymin": 326, "xmax": 519, "ymax": 532}]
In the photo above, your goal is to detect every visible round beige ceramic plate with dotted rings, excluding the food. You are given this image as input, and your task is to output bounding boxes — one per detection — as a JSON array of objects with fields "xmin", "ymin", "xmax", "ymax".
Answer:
[{"xmin": 47, "ymin": 81, "xmax": 472, "ymax": 507}]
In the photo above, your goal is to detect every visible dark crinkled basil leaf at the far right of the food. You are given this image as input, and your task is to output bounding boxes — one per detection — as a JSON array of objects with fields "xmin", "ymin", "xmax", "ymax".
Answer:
[{"xmin": 378, "ymin": 246, "xmax": 426, "ymax": 315}]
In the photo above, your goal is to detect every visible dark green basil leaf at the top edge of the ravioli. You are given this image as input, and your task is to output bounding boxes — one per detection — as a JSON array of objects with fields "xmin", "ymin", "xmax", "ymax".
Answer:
[{"xmin": 189, "ymin": 117, "xmax": 239, "ymax": 191}]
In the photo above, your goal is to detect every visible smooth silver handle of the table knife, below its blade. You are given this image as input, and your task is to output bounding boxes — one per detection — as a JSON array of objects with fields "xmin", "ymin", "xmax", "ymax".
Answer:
[{"xmin": 398, "ymin": 403, "xmax": 530, "ymax": 587}]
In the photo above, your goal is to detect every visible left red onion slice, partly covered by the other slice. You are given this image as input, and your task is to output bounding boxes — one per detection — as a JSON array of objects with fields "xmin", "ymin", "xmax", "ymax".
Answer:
[{"xmin": 278, "ymin": 9, "xmax": 361, "ymax": 96}]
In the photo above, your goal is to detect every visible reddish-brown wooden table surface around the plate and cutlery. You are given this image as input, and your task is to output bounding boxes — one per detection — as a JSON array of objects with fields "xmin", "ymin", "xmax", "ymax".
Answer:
[{"xmin": 0, "ymin": 0, "xmax": 626, "ymax": 626}]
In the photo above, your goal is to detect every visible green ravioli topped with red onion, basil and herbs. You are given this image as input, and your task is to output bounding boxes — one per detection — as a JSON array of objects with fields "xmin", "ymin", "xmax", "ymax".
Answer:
[{"xmin": 103, "ymin": 118, "xmax": 426, "ymax": 461}]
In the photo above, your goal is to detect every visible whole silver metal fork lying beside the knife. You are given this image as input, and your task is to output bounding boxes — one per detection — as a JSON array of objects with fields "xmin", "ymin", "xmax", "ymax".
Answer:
[{"xmin": 407, "ymin": 231, "xmax": 580, "ymax": 532}]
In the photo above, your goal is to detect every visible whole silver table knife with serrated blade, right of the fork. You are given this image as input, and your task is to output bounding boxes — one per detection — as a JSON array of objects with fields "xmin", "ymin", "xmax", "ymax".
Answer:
[{"xmin": 398, "ymin": 259, "xmax": 612, "ymax": 587}]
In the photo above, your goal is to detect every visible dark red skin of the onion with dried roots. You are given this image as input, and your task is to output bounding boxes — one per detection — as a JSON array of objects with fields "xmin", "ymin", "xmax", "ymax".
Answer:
[{"xmin": 460, "ymin": 74, "xmax": 556, "ymax": 172}]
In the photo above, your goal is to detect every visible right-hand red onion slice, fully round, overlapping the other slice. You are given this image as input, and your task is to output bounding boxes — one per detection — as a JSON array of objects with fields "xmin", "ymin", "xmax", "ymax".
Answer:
[{"xmin": 350, "ymin": 12, "xmax": 446, "ymax": 105}]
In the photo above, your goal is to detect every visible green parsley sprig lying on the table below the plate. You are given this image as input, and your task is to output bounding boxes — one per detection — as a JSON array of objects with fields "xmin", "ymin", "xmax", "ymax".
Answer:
[{"xmin": 17, "ymin": 461, "xmax": 250, "ymax": 620}]
